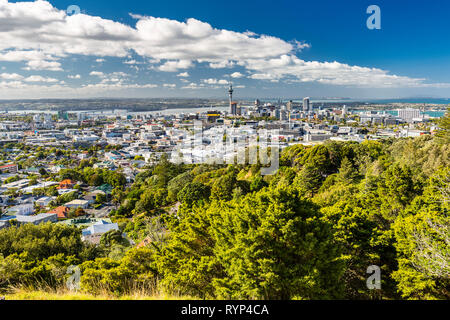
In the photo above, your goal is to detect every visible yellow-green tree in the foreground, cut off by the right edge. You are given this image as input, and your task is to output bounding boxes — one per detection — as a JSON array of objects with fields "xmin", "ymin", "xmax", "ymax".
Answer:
[{"xmin": 393, "ymin": 167, "xmax": 450, "ymax": 299}]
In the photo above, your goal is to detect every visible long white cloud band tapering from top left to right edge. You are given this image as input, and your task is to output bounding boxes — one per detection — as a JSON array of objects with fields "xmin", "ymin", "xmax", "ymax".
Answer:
[{"xmin": 0, "ymin": 0, "xmax": 447, "ymax": 88}]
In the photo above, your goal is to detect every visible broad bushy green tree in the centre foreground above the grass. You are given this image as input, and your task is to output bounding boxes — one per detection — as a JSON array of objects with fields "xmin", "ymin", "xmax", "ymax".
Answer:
[{"xmin": 158, "ymin": 185, "xmax": 343, "ymax": 299}]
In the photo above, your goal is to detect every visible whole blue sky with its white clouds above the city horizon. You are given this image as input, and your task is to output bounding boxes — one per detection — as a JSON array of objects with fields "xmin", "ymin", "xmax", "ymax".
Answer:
[{"xmin": 0, "ymin": 0, "xmax": 450, "ymax": 99}]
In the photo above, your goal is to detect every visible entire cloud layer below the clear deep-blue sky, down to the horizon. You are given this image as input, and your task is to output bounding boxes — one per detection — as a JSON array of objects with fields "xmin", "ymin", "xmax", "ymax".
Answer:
[{"xmin": 0, "ymin": 0, "xmax": 450, "ymax": 98}]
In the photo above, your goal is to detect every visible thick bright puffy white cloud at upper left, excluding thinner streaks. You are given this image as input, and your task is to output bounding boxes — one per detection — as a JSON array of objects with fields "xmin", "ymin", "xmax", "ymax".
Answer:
[{"xmin": 0, "ymin": 0, "xmax": 294, "ymax": 71}]
